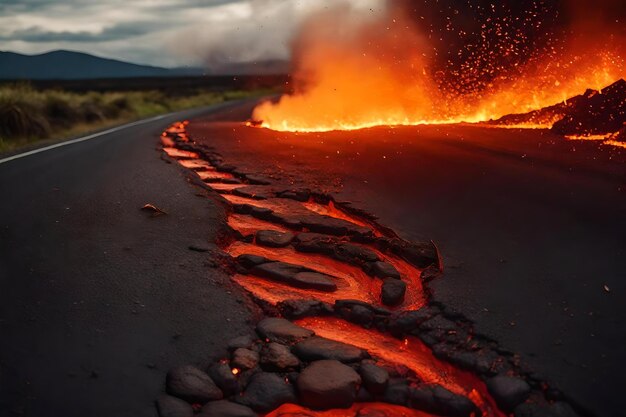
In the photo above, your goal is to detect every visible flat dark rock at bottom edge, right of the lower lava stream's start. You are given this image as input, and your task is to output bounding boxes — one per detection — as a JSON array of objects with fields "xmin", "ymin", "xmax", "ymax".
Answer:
[{"xmin": 409, "ymin": 385, "xmax": 478, "ymax": 417}]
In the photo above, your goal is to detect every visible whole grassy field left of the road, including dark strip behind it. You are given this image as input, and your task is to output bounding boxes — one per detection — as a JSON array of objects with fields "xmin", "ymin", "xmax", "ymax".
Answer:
[{"xmin": 0, "ymin": 77, "xmax": 280, "ymax": 153}]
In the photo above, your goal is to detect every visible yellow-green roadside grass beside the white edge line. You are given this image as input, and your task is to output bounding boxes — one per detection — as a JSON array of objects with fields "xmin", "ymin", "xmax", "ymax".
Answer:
[{"xmin": 0, "ymin": 83, "xmax": 268, "ymax": 153}]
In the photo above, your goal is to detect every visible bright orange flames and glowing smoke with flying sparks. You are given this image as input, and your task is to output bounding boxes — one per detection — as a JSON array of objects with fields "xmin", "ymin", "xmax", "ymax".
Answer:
[{"xmin": 253, "ymin": 1, "xmax": 625, "ymax": 132}]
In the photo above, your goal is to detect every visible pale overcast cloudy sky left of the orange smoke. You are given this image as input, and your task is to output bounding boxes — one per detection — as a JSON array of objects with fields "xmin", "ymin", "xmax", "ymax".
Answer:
[{"xmin": 0, "ymin": 0, "xmax": 384, "ymax": 66}]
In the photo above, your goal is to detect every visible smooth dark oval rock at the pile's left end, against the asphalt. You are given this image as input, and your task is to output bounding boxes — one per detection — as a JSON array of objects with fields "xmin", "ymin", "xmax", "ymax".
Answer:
[{"xmin": 166, "ymin": 365, "xmax": 222, "ymax": 404}]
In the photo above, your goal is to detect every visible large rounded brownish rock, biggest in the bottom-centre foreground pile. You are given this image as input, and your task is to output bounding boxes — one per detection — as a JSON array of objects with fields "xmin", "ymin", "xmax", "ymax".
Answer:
[{"xmin": 297, "ymin": 360, "xmax": 361, "ymax": 410}]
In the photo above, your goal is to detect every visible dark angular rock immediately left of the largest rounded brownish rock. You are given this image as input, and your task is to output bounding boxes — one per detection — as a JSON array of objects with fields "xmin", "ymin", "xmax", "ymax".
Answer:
[{"xmin": 236, "ymin": 372, "xmax": 297, "ymax": 413}]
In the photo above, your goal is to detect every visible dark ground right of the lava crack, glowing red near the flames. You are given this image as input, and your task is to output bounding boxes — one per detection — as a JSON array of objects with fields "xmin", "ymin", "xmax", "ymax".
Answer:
[{"xmin": 189, "ymin": 100, "xmax": 626, "ymax": 416}]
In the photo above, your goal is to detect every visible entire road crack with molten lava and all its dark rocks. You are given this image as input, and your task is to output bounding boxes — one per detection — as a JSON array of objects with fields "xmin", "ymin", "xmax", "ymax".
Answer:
[{"xmin": 159, "ymin": 123, "xmax": 580, "ymax": 417}]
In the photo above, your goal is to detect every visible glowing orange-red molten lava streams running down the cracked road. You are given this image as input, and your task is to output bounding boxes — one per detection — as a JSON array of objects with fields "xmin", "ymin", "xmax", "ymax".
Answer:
[{"xmin": 162, "ymin": 121, "xmax": 520, "ymax": 417}]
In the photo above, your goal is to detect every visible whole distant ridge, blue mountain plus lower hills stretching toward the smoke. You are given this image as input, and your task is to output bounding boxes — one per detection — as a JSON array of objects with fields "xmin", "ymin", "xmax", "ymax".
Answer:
[{"xmin": 0, "ymin": 51, "xmax": 288, "ymax": 80}]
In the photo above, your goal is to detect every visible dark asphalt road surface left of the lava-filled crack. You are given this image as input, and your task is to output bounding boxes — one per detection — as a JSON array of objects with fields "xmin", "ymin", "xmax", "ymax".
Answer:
[{"xmin": 0, "ymin": 102, "xmax": 251, "ymax": 417}]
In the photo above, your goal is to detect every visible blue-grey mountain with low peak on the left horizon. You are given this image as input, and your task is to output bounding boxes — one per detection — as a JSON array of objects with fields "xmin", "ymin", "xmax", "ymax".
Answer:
[{"xmin": 0, "ymin": 51, "xmax": 202, "ymax": 80}]
